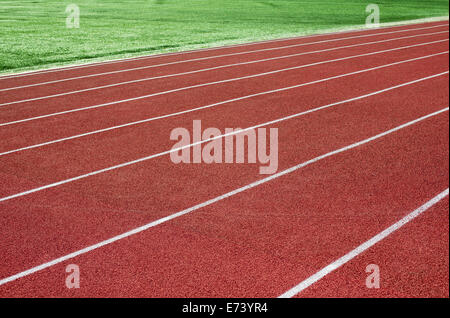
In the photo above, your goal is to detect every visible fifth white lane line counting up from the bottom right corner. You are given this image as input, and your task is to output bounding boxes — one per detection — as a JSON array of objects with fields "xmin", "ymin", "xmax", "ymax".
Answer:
[{"xmin": 0, "ymin": 39, "xmax": 448, "ymax": 127}]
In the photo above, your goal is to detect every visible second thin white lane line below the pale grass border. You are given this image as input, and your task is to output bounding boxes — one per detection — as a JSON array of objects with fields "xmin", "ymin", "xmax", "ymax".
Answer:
[{"xmin": 0, "ymin": 31, "xmax": 449, "ymax": 102}]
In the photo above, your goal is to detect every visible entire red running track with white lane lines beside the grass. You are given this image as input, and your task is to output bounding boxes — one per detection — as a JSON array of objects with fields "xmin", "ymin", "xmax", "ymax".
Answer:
[{"xmin": 0, "ymin": 21, "xmax": 449, "ymax": 297}]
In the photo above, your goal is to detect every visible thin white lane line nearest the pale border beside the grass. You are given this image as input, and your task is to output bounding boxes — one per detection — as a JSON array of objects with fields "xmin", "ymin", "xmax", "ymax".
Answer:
[{"xmin": 0, "ymin": 30, "xmax": 449, "ymax": 92}]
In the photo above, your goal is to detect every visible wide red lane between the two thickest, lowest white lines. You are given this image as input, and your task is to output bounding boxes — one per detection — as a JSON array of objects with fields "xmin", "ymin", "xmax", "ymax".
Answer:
[{"xmin": 0, "ymin": 100, "xmax": 449, "ymax": 297}]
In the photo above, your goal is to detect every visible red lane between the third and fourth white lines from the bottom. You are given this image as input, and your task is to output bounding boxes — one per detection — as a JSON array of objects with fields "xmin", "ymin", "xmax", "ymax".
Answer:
[{"xmin": 0, "ymin": 50, "xmax": 448, "ymax": 190}]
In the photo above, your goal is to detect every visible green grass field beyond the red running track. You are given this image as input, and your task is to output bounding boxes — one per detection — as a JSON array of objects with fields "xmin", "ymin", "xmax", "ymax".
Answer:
[{"xmin": 0, "ymin": 0, "xmax": 449, "ymax": 73}]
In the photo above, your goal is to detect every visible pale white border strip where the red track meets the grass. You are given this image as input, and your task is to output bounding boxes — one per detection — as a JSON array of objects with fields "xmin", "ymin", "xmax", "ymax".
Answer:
[{"xmin": 0, "ymin": 16, "xmax": 449, "ymax": 81}]
